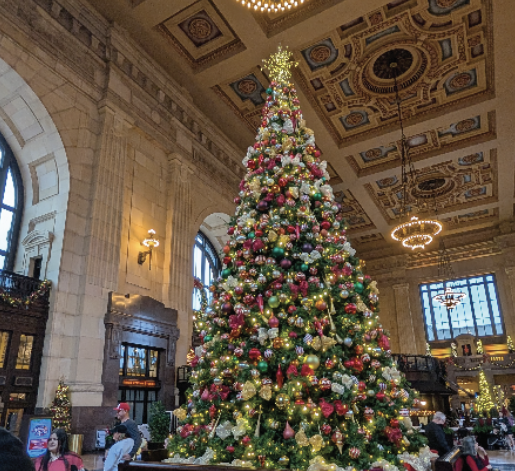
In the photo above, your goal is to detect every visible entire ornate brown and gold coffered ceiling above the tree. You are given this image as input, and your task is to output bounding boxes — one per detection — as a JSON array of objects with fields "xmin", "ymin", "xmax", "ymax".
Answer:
[{"xmin": 86, "ymin": 0, "xmax": 515, "ymax": 254}]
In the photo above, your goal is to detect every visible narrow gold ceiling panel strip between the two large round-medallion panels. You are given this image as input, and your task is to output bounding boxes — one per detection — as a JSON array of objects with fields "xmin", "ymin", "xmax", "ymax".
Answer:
[{"xmin": 346, "ymin": 111, "xmax": 497, "ymax": 177}]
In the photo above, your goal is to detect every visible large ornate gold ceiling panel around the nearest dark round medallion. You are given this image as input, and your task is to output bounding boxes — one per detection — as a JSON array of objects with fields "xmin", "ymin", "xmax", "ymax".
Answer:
[{"xmin": 294, "ymin": 0, "xmax": 495, "ymax": 147}]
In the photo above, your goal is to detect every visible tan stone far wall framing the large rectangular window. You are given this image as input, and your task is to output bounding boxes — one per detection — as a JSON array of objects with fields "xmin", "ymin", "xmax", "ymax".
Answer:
[{"xmin": 359, "ymin": 223, "xmax": 515, "ymax": 355}]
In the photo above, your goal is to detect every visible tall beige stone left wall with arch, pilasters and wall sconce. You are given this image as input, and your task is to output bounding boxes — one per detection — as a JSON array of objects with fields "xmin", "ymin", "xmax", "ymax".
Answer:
[{"xmin": 0, "ymin": 0, "xmax": 238, "ymax": 422}]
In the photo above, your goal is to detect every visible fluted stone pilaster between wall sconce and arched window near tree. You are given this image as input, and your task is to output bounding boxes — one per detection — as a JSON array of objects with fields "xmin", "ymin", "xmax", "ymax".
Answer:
[{"xmin": 163, "ymin": 154, "xmax": 195, "ymax": 366}]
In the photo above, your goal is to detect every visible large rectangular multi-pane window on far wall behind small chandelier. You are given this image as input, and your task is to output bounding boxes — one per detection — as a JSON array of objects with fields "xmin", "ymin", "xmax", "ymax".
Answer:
[{"xmin": 420, "ymin": 275, "xmax": 504, "ymax": 342}]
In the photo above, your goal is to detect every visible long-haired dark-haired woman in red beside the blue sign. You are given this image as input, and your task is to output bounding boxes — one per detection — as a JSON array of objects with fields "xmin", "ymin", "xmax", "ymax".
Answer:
[{"xmin": 35, "ymin": 428, "xmax": 84, "ymax": 471}]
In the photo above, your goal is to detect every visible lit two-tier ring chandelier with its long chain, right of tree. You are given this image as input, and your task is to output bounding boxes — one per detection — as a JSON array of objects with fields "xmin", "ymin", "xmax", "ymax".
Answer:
[{"xmin": 385, "ymin": 57, "xmax": 442, "ymax": 250}]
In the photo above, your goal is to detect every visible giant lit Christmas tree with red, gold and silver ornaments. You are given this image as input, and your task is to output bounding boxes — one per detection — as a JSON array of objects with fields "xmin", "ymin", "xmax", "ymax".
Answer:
[{"xmin": 169, "ymin": 48, "xmax": 427, "ymax": 471}]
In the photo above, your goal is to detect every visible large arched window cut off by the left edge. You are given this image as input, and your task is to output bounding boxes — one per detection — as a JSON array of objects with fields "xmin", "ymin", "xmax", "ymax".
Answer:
[{"xmin": 0, "ymin": 135, "xmax": 23, "ymax": 270}]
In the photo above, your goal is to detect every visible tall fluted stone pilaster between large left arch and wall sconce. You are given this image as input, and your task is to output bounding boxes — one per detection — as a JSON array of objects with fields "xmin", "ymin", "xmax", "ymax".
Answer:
[{"xmin": 69, "ymin": 106, "xmax": 130, "ymax": 407}]
